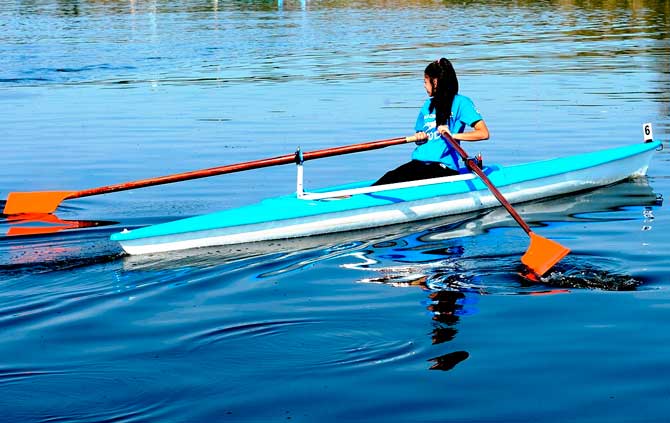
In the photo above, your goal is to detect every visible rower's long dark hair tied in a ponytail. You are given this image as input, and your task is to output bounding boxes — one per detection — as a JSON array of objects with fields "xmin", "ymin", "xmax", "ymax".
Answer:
[{"xmin": 424, "ymin": 57, "xmax": 458, "ymax": 126}]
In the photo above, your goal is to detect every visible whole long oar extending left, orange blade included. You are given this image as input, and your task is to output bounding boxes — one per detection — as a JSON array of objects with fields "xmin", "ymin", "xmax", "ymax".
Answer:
[{"xmin": 3, "ymin": 136, "xmax": 416, "ymax": 215}]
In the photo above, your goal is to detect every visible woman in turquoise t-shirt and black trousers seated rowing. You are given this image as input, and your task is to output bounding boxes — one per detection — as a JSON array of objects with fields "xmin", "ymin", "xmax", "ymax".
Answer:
[{"xmin": 373, "ymin": 58, "xmax": 489, "ymax": 185}]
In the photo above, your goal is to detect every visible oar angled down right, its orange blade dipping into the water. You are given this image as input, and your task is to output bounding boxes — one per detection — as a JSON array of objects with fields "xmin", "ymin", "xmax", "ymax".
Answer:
[{"xmin": 443, "ymin": 134, "xmax": 570, "ymax": 276}]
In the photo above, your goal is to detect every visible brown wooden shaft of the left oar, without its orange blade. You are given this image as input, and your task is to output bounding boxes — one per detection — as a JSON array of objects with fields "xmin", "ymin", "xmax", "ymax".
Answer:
[{"xmin": 65, "ymin": 137, "xmax": 416, "ymax": 199}]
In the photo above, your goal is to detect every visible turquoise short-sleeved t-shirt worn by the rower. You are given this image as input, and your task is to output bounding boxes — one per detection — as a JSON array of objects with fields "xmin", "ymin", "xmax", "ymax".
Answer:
[{"xmin": 412, "ymin": 94, "xmax": 482, "ymax": 170}]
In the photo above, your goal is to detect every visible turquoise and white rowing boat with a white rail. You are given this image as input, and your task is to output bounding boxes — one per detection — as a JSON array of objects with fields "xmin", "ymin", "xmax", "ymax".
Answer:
[{"xmin": 111, "ymin": 141, "xmax": 662, "ymax": 254}]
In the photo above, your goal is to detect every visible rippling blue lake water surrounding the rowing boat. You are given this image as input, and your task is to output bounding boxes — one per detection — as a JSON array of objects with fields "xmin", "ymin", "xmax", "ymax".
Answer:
[{"xmin": 0, "ymin": 0, "xmax": 670, "ymax": 422}]
